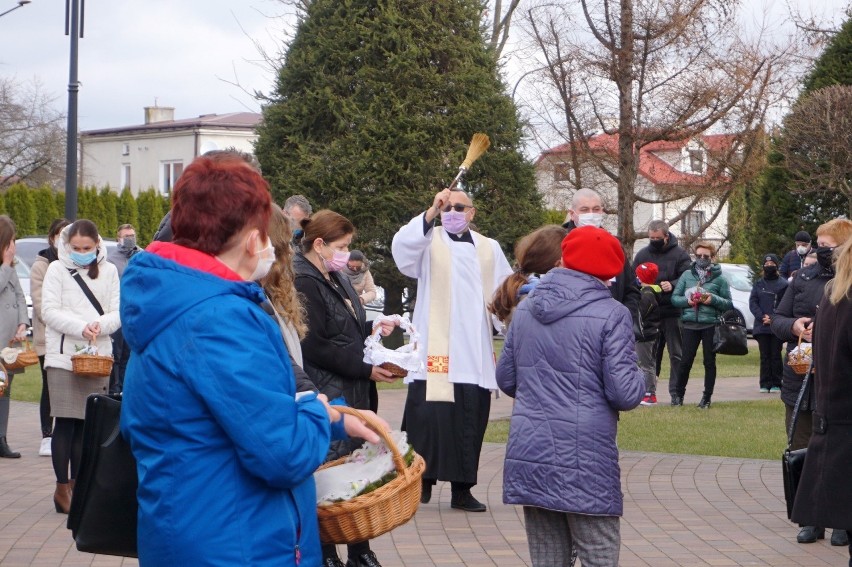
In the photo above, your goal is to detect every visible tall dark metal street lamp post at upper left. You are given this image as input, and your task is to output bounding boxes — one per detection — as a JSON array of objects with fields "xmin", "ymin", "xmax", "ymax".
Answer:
[{"xmin": 65, "ymin": 0, "xmax": 83, "ymax": 221}]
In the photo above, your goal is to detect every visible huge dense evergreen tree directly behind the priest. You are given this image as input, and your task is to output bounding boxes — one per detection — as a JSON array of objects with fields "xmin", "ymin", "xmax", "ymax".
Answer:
[{"xmin": 256, "ymin": 0, "xmax": 542, "ymax": 320}]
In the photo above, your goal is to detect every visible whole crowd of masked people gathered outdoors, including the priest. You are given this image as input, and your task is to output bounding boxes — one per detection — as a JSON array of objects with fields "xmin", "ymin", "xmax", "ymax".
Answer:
[{"xmin": 0, "ymin": 151, "xmax": 852, "ymax": 567}]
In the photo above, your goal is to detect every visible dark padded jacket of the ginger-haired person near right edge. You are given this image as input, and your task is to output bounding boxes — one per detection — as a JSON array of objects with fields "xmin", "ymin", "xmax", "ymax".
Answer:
[{"xmin": 770, "ymin": 264, "xmax": 834, "ymax": 411}]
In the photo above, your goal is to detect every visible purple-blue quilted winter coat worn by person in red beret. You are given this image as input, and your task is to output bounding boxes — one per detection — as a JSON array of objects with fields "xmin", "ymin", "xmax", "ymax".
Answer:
[{"xmin": 497, "ymin": 268, "xmax": 645, "ymax": 516}]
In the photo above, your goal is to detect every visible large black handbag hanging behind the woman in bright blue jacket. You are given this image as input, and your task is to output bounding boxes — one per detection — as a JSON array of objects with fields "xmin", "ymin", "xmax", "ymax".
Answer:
[{"xmin": 68, "ymin": 394, "xmax": 138, "ymax": 557}]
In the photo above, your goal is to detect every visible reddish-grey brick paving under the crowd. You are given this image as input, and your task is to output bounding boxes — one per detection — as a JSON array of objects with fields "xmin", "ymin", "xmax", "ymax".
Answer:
[{"xmin": 0, "ymin": 379, "xmax": 848, "ymax": 567}]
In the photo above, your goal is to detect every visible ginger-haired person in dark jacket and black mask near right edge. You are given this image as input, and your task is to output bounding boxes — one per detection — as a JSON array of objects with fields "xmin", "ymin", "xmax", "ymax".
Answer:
[{"xmin": 771, "ymin": 219, "xmax": 852, "ymax": 545}]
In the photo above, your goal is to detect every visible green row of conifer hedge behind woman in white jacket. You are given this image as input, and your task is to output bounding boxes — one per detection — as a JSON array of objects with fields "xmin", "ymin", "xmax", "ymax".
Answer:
[{"xmin": 0, "ymin": 184, "xmax": 169, "ymax": 246}]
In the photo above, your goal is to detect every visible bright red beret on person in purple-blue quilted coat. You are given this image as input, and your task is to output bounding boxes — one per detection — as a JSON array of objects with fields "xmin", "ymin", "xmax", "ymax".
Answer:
[{"xmin": 562, "ymin": 226, "xmax": 624, "ymax": 280}]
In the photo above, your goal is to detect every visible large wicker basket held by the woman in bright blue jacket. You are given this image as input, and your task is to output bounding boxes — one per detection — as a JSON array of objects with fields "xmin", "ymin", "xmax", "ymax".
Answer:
[{"xmin": 317, "ymin": 406, "xmax": 426, "ymax": 543}]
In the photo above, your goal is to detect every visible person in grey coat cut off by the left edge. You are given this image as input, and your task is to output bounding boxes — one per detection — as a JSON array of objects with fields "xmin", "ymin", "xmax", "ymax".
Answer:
[{"xmin": 0, "ymin": 215, "xmax": 29, "ymax": 459}]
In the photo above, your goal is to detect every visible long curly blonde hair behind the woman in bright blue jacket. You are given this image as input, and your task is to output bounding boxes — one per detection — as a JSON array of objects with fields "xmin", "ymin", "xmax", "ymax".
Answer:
[{"xmin": 263, "ymin": 203, "xmax": 308, "ymax": 339}]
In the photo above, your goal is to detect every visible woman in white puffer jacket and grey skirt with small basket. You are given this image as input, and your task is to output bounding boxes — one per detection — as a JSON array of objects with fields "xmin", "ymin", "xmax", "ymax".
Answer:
[{"xmin": 41, "ymin": 219, "xmax": 121, "ymax": 514}]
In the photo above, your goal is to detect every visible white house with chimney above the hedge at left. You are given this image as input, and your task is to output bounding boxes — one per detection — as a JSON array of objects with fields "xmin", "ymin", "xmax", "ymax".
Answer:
[{"xmin": 80, "ymin": 106, "xmax": 261, "ymax": 195}]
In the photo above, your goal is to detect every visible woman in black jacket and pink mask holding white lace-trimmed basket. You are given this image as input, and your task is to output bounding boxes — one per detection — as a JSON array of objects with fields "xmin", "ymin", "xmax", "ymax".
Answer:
[{"xmin": 294, "ymin": 210, "xmax": 394, "ymax": 567}]
